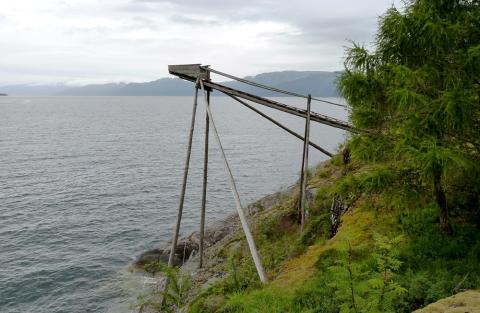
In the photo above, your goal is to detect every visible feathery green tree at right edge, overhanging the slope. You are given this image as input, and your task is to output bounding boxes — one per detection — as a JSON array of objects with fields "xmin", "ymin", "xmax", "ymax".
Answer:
[{"xmin": 340, "ymin": 0, "xmax": 480, "ymax": 232}]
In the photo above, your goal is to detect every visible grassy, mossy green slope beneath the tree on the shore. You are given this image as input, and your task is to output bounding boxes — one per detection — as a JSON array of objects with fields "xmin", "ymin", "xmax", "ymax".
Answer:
[{"xmin": 185, "ymin": 157, "xmax": 480, "ymax": 313}]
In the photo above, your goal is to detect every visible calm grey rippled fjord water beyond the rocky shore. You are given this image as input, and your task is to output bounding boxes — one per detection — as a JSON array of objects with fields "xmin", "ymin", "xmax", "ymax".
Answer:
[{"xmin": 0, "ymin": 97, "xmax": 346, "ymax": 313}]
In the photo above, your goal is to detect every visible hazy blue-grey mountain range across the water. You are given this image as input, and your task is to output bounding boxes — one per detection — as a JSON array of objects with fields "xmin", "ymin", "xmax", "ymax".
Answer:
[{"xmin": 0, "ymin": 71, "xmax": 341, "ymax": 97}]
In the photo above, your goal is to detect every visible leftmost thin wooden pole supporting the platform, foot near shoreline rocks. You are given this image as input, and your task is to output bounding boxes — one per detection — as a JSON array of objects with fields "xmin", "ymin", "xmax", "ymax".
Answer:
[{"xmin": 168, "ymin": 80, "xmax": 198, "ymax": 267}]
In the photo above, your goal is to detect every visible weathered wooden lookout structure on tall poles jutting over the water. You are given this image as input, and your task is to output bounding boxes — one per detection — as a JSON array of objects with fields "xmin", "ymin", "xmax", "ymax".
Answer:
[{"xmin": 168, "ymin": 64, "xmax": 359, "ymax": 283}]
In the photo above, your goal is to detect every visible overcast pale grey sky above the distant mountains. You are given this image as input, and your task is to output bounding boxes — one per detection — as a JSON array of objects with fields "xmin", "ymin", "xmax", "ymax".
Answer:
[{"xmin": 0, "ymin": 0, "xmax": 400, "ymax": 84}]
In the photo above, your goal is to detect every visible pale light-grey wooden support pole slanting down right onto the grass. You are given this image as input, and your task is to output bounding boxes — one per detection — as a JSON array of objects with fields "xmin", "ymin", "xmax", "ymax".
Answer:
[{"xmin": 200, "ymin": 81, "xmax": 267, "ymax": 283}]
